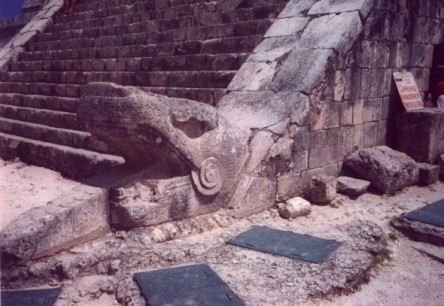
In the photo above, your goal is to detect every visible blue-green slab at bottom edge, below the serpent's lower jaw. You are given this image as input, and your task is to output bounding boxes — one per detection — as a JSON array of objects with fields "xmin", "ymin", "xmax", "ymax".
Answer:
[{"xmin": 134, "ymin": 264, "xmax": 245, "ymax": 306}]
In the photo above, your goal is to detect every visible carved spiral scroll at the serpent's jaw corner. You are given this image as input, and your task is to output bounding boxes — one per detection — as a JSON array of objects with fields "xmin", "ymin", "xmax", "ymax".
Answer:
[{"xmin": 191, "ymin": 157, "xmax": 222, "ymax": 196}]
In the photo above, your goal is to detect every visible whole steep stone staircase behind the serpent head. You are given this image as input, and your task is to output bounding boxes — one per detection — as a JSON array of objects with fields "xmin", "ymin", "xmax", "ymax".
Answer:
[{"xmin": 0, "ymin": 0, "xmax": 287, "ymax": 177}]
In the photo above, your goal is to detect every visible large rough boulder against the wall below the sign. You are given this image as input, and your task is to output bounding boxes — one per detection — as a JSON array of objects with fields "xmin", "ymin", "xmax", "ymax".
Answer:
[{"xmin": 344, "ymin": 146, "xmax": 419, "ymax": 193}]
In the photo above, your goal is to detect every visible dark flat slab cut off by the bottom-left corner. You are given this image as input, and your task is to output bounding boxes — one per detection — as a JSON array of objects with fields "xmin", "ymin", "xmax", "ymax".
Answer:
[{"xmin": 0, "ymin": 287, "xmax": 60, "ymax": 306}]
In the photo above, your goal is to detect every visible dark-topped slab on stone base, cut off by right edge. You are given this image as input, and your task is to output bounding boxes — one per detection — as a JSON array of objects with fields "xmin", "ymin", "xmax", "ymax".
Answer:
[{"xmin": 391, "ymin": 200, "xmax": 444, "ymax": 246}]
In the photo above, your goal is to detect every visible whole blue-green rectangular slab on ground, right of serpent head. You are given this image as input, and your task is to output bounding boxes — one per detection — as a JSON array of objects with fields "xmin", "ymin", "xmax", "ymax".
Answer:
[{"xmin": 227, "ymin": 226, "xmax": 341, "ymax": 263}]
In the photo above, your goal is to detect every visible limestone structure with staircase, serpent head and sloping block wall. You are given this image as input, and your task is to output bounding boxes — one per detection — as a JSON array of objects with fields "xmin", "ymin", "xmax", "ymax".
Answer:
[{"xmin": 0, "ymin": 0, "xmax": 444, "ymax": 226}]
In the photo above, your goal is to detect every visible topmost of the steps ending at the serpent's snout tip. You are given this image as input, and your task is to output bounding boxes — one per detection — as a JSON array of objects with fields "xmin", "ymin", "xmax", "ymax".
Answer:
[{"xmin": 0, "ymin": 81, "xmax": 82, "ymax": 98}]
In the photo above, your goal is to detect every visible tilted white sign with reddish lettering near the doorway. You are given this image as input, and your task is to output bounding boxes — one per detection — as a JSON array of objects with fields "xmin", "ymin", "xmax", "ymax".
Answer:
[{"xmin": 393, "ymin": 72, "xmax": 424, "ymax": 111}]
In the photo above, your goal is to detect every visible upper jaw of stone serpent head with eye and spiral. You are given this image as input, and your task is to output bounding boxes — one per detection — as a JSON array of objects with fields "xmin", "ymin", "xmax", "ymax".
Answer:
[{"xmin": 78, "ymin": 83, "xmax": 249, "ymax": 203}]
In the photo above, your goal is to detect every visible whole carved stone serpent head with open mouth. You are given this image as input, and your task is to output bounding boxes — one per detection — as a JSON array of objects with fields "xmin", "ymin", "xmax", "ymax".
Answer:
[{"xmin": 78, "ymin": 83, "xmax": 274, "ymax": 228}]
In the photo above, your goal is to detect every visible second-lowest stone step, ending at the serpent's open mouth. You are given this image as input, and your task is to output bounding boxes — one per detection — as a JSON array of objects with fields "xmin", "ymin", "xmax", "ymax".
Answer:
[{"xmin": 0, "ymin": 117, "xmax": 110, "ymax": 153}]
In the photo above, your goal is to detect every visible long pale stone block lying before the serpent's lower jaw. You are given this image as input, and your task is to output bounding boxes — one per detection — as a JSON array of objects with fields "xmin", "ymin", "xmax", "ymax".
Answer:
[{"xmin": 0, "ymin": 185, "xmax": 110, "ymax": 261}]
